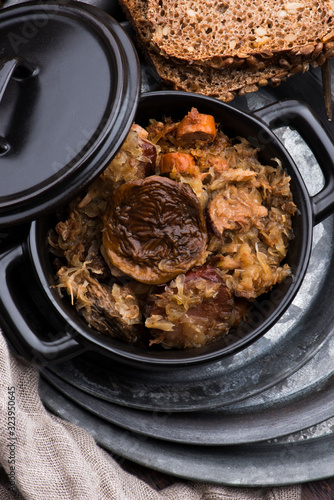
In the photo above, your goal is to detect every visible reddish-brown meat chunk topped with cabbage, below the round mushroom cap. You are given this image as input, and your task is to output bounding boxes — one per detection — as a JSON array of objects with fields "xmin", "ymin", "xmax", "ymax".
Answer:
[{"xmin": 145, "ymin": 265, "xmax": 236, "ymax": 349}]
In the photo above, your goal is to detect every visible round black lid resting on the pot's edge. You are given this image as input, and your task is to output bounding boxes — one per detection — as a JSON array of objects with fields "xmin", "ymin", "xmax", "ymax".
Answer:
[{"xmin": 0, "ymin": 2, "xmax": 140, "ymax": 226}]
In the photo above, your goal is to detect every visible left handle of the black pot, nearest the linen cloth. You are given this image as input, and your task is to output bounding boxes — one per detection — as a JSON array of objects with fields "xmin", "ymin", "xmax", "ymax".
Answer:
[{"xmin": 0, "ymin": 244, "xmax": 86, "ymax": 365}]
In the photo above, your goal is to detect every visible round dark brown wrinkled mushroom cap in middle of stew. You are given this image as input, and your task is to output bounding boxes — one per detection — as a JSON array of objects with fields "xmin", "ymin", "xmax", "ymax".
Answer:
[{"xmin": 103, "ymin": 175, "xmax": 207, "ymax": 284}]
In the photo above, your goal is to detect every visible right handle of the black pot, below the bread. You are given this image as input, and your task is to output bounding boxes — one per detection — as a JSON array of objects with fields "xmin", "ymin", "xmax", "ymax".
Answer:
[{"xmin": 253, "ymin": 99, "xmax": 334, "ymax": 224}]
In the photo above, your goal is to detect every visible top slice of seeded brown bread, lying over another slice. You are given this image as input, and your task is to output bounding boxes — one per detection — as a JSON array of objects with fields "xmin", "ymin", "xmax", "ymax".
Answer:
[{"xmin": 147, "ymin": 0, "xmax": 334, "ymax": 69}]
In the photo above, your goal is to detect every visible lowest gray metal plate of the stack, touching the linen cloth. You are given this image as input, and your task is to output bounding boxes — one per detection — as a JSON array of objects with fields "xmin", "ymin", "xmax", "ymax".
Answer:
[{"xmin": 40, "ymin": 381, "xmax": 334, "ymax": 487}]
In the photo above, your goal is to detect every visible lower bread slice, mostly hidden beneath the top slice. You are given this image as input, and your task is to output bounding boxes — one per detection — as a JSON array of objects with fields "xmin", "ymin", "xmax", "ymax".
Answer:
[{"xmin": 120, "ymin": 0, "xmax": 334, "ymax": 102}]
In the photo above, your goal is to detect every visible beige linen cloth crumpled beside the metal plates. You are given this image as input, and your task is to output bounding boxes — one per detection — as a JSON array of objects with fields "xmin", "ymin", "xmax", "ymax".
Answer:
[{"xmin": 0, "ymin": 331, "xmax": 301, "ymax": 500}]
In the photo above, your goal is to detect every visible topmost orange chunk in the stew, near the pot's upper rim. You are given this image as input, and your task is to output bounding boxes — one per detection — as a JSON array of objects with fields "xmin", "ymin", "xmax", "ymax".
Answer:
[{"xmin": 176, "ymin": 108, "xmax": 217, "ymax": 148}]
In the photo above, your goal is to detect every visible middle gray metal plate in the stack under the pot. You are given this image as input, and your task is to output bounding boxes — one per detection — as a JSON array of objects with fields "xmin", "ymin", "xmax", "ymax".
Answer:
[{"xmin": 41, "ymin": 328, "xmax": 334, "ymax": 446}]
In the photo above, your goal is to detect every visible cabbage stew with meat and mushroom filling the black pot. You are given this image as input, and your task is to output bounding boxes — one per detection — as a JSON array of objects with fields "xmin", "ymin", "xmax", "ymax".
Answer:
[{"xmin": 48, "ymin": 108, "xmax": 297, "ymax": 349}]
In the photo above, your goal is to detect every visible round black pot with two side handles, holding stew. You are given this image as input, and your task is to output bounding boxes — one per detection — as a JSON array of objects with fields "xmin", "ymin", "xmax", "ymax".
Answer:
[{"xmin": 0, "ymin": 91, "xmax": 334, "ymax": 369}]
